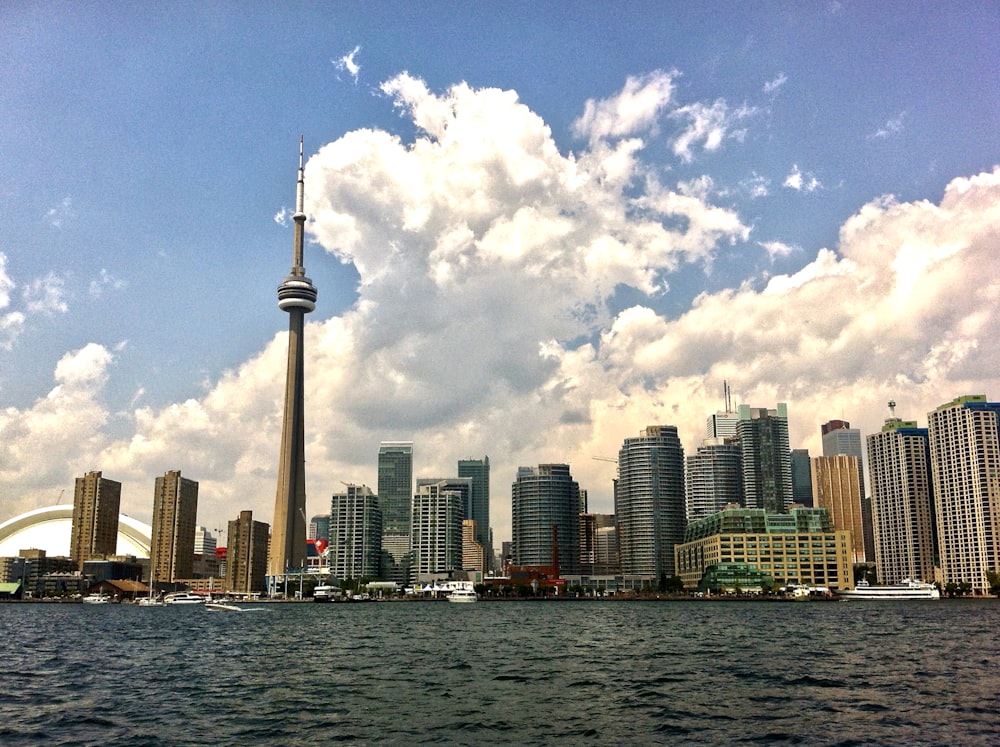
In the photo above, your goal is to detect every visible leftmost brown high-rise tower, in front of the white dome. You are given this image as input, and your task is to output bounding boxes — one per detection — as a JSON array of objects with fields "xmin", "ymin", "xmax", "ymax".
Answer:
[{"xmin": 69, "ymin": 472, "xmax": 122, "ymax": 571}]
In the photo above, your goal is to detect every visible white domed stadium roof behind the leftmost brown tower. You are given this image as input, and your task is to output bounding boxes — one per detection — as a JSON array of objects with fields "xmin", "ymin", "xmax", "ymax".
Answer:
[{"xmin": 0, "ymin": 504, "xmax": 153, "ymax": 558}]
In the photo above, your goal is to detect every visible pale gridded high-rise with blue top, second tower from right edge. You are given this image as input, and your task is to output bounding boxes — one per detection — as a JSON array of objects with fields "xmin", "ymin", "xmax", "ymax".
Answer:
[{"xmin": 867, "ymin": 417, "xmax": 935, "ymax": 584}]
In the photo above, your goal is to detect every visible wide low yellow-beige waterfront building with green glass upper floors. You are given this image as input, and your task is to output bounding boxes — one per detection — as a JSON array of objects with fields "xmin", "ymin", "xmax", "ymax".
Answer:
[{"xmin": 675, "ymin": 507, "xmax": 854, "ymax": 591}]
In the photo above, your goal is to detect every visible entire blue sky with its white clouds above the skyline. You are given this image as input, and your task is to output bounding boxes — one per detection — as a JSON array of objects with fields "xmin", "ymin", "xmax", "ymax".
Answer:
[{"xmin": 0, "ymin": 2, "xmax": 1000, "ymax": 539}]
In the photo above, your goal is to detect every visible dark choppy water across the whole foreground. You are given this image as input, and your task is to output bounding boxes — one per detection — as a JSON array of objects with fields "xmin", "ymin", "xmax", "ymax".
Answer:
[{"xmin": 0, "ymin": 600, "xmax": 1000, "ymax": 747}]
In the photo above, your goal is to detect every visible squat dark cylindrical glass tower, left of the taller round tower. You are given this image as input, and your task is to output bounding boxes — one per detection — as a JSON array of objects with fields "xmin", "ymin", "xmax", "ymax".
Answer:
[{"xmin": 511, "ymin": 464, "xmax": 580, "ymax": 575}]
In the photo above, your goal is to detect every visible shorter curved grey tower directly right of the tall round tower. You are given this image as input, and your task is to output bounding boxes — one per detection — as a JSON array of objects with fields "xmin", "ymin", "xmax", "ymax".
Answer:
[{"xmin": 685, "ymin": 437, "xmax": 743, "ymax": 521}]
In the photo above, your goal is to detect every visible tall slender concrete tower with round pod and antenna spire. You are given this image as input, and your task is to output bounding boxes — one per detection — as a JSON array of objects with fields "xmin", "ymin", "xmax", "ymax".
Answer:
[{"xmin": 267, "ymin": 138, "xmax": 316, "ymax": 576}]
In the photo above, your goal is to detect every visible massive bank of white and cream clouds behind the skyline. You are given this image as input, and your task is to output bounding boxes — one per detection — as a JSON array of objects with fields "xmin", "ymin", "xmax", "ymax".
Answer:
[{"xmin": 0, "ymin": 73, "xmax": 1000, "ymax": 540}]
